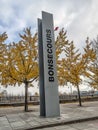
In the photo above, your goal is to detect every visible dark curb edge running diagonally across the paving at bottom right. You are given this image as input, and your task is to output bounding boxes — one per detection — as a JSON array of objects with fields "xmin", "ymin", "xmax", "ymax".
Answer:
[{"xmin": 25, "ymin": 116, "xmax": 98, "ymax": 130}]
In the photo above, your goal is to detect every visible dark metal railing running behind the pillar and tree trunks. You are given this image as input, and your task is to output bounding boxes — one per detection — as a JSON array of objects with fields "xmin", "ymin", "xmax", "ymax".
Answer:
[{"xmin": 0, "ymin": 94, "xmax": 98, "ymax": 104}]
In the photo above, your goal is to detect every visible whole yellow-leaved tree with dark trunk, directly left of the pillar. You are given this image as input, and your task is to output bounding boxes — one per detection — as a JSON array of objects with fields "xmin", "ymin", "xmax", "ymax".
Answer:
[{"xmin": 1, "ymin": 28, "xmax": 38, "ymax": 111}]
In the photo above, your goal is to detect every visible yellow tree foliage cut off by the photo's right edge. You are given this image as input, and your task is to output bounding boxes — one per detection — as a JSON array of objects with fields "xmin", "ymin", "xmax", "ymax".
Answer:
[{"xmin": 83, "ymin": 38, "xmax": 98, "ymax": 89}]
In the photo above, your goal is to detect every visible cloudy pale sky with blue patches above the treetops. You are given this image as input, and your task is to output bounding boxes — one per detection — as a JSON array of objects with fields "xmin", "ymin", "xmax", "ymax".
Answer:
[{"xmin": 0, "ymin": 0, "xmax": 98, "ymax": 48}]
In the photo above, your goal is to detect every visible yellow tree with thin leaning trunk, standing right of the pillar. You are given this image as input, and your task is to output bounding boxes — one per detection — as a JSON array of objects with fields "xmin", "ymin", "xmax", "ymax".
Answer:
[{"xmin": 60, "ymin": 42, "xmax": 84, "ymax": 106}]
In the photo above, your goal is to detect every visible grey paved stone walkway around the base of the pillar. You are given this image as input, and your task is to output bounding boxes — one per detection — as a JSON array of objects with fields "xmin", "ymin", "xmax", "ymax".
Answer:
[{"xmin": 0, "ymin": 101, "xmax": 98, "ymax": 130}]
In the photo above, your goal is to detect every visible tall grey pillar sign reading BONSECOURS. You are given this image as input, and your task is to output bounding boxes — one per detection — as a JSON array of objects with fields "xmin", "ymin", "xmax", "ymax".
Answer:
[{"xmin": 38, "ymin": 12, "xmax": 60, "ymax": 117}]
